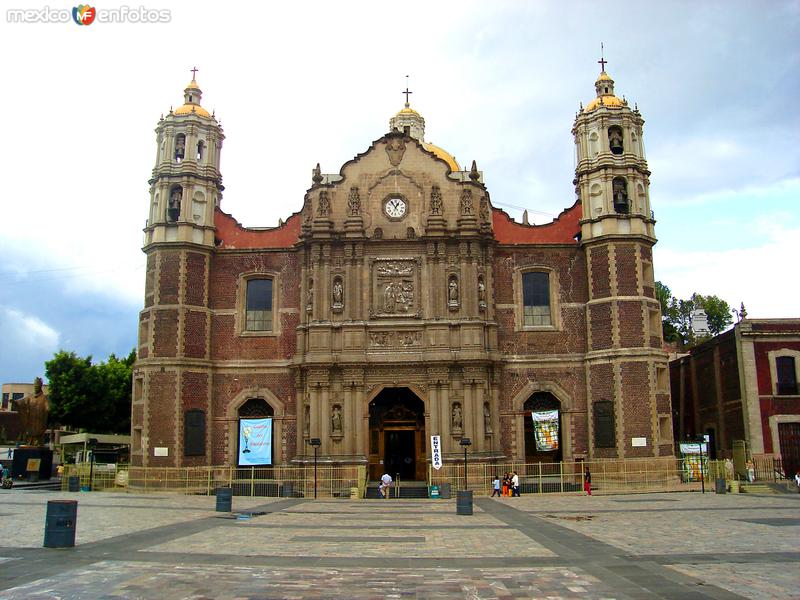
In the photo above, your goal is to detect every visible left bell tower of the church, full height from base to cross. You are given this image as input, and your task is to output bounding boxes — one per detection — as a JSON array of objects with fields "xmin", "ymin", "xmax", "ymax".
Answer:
[{"xmin": 131, "ymin": 69, "xmax": 225, "ymax": 467}]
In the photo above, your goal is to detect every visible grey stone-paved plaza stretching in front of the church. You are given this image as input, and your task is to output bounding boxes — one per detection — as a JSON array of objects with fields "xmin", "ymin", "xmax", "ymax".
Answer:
[{"xmin": 0, "ymin": 489, "xmax": 800, "ymax": 600}]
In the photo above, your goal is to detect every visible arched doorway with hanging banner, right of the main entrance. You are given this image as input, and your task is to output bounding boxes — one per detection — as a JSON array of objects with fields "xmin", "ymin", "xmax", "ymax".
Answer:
[{"xmin": 523, "ymin": 392, "xmax": 564, "ymax": 463}]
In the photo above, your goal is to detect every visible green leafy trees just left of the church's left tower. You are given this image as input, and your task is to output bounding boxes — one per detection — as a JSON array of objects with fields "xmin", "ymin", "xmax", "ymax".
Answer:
[{"xmin": 45, "ymin": 350, "xmax": 136, "ymax": 433}]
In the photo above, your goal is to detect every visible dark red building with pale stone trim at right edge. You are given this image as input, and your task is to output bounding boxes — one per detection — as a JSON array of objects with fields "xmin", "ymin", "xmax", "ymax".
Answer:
[{"xmin": 670, "ymin": 319, "xmax": 800, "ymax": 476}]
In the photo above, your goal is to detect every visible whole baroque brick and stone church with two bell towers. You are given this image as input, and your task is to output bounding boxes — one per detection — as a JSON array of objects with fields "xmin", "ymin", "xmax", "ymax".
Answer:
[{"xmin": 132, "ymin": 61, "xmax": 673, "ymax": 480}]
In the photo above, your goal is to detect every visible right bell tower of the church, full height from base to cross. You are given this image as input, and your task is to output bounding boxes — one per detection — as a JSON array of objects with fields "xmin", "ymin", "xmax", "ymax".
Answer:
[{"xmin": 572, "ymin": 58, "xmax": 673, "ymax": 458}]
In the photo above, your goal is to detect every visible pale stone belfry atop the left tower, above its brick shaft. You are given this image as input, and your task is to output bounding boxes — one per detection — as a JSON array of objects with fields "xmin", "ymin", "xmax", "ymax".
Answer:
[{"xmin": 145, "ymin": 69, "xmax": 225, "ymax": 247}]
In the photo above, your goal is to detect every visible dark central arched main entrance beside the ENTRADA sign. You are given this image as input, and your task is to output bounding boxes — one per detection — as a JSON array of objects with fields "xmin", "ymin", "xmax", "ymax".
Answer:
[{"xmin": 369, "ymin": 388, "xmax": 427, "ymax": 481}]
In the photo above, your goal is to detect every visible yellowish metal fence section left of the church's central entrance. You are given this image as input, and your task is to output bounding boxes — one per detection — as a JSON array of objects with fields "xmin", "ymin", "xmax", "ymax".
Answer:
[{"xmin": 62, "ymin": 465, "xmax": 366, "ymax": 498}]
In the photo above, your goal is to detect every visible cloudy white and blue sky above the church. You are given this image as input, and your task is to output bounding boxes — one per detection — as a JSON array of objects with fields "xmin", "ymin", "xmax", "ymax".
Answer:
[{"xmin": 0, "ymin": 0, "xmax": 800, "ymax": 382}]
